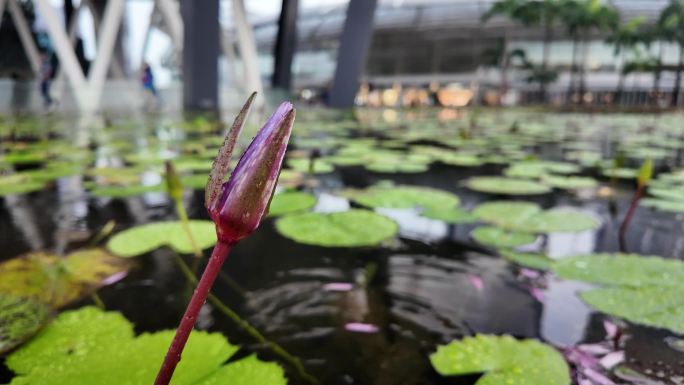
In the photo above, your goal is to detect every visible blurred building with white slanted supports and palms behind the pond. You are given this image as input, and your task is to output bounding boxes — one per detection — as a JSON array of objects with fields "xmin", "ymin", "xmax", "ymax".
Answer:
[{"xmin": 0, "ymin": 0, "xmax": 684, "ymax": 110}]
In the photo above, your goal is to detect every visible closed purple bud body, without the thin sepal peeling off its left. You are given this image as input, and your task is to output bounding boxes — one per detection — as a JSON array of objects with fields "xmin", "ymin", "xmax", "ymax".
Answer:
[{"xmin": 206, "ymin": 102, "xmax": 295, "ymax": 243}]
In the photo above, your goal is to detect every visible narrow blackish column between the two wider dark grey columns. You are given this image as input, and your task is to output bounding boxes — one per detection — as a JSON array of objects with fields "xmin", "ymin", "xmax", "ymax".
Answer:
[{"xmin": 272, "ymin": 0, "xmax": 299, "ymax": 91}]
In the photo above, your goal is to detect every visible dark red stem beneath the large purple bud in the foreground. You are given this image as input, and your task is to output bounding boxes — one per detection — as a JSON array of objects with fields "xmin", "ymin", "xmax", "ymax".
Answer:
[{"xmin": 154, "ymin": 241, "xmax": 233, "ymax": 385}]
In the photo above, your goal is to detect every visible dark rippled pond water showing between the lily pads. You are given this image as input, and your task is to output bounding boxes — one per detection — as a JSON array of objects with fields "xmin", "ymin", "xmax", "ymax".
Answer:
[{"xmin": 0, "ymin": 112, "xmax": 684, "ymax": 385}]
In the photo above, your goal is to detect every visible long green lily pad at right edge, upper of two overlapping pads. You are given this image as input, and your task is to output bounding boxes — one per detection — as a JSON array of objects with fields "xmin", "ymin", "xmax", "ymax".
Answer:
[{"xmin": 553, "ymin": 254, "xmax": 684, "ymax": 287}]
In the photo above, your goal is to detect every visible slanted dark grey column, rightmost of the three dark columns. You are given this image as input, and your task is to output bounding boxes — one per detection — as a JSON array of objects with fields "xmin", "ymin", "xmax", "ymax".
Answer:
[{"xmin": 328, "ymin": 0, "xmax": 378, "ymax": 108}]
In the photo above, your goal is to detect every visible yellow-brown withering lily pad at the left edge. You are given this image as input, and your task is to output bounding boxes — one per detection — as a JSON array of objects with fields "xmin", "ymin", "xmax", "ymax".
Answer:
[{"xmin": 0, "ymin": 249, "xmax": 129, "ymax": 308}]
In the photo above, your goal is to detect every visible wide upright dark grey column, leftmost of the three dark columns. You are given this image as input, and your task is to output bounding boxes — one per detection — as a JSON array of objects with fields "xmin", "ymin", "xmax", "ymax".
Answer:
[{"xmin": 181, "ymin": 0, "xmax": 219, "ymax": 111}]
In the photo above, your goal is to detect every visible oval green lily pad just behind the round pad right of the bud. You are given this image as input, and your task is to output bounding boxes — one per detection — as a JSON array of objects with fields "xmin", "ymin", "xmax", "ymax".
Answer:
[{"xmin": 348, "ymin": 186, "xmax": 460, "ymax": 209}]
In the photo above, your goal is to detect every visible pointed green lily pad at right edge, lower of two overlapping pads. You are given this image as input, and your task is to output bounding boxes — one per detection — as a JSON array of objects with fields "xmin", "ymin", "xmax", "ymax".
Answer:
[{"xmin": 581, "ymin": 286, "xmax": 684, "ymax": 334}]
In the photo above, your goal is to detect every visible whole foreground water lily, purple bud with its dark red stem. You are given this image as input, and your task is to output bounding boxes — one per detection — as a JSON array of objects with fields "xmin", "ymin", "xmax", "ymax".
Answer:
[{"xmin": 155, "ymin": 94, "xmax": 295, "ymax": 385}]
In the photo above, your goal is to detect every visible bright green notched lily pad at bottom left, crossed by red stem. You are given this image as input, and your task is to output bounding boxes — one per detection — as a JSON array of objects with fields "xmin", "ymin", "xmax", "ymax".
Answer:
[{"xmin": 7, "ymin": 307, "xmax": 287, "ymax": 385}]
